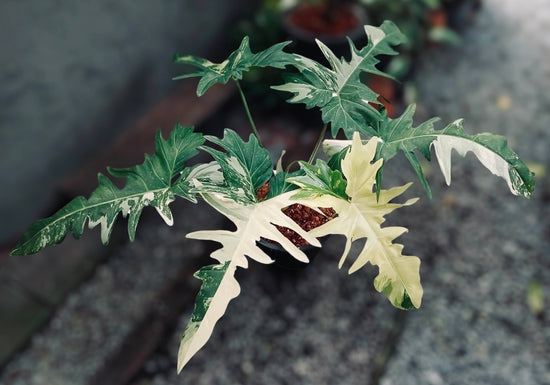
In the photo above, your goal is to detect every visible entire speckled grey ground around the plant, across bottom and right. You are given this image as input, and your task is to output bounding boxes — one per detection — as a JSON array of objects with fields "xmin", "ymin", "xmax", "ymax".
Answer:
[{"xmin": 0, "ymin": 0, "xmax": 550, "ymax": 385}]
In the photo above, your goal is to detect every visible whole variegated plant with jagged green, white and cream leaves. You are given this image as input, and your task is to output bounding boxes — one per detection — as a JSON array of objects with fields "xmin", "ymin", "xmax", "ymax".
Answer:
[{"xmin": 12, "ymin": 21, "xmax": 534, "ymax": 371}]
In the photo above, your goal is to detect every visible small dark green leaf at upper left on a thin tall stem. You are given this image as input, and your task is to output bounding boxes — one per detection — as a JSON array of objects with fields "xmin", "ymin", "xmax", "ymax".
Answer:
[{"xmin": 174, "ymin": 36, "xmax": 295, "ymax": 96}]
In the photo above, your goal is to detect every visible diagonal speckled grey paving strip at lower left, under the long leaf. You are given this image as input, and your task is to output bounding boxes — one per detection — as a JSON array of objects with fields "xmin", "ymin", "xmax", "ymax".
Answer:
[{"xmin": 0, "ymin": 204, "xmax": 220, "ymax": 385}]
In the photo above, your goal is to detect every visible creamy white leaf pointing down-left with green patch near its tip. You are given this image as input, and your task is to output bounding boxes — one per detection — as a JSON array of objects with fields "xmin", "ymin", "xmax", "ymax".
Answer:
[{"xmin": 178, "ymin": 192, "xmax": 321, "ymax": 371}]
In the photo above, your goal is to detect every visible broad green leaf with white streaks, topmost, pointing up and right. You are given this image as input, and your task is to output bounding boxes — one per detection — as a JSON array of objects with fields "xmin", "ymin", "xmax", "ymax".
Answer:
[{"xmin": 272, "ymin": 21, "xmax": 405, "ymax": 138}]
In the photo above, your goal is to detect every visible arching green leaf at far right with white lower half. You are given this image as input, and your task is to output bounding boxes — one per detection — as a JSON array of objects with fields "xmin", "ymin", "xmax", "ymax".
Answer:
[{"xmin": 377, "ymin": 105, "xmax": 535, "ymax": 197}]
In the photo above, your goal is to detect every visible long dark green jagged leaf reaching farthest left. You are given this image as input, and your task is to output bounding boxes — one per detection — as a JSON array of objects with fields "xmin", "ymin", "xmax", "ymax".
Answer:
[{"xmin": 12, "ymin": 125, "xmax": 204, "ymax": 255}]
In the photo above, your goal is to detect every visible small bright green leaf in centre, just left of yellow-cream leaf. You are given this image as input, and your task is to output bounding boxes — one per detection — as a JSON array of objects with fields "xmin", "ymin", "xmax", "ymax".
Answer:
[{"xmin": 287, "ymin": 159, "xmax": 348, "ymax": 199}]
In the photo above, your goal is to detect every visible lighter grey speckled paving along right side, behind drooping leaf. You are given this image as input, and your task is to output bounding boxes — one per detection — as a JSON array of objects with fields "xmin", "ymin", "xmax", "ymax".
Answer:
[{"xmin": 380, "ymin": 0, "xmax": 550, "ymax": 385}]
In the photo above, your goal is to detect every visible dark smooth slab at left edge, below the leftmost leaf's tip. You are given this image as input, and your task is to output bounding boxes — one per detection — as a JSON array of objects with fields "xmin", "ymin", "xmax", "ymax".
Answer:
[{"xmin": 0, "ymin": 232, "xmax": 117, "ymax": 366}]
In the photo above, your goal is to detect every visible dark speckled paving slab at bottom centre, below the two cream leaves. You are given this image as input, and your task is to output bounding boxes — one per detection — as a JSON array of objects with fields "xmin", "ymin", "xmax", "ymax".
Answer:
[{"xmin": 133, "ymin": 240, "xmax": 402, "ymax": 385}]
